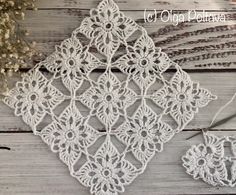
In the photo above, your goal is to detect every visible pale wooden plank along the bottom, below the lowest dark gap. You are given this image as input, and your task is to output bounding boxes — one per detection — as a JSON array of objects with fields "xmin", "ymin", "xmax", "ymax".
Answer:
[{"xmin": 0, "ymin": 131, "xmax": 236, "ymax": 195}]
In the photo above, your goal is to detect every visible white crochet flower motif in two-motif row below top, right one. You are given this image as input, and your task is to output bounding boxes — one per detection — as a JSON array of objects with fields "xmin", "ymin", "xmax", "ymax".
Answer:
[{"xmin": 114, "ymin": 31, "xmax": 174, "ymax": 88}]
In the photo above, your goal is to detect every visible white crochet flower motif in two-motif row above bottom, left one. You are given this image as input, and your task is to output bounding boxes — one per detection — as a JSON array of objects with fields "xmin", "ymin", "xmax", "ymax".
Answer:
[{"xmin": 41, "ymin": 104, "xmax": 99, "ymax": 167}]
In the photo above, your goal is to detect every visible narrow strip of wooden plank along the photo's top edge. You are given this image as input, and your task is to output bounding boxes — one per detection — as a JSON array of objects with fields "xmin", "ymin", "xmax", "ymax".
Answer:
[{"xmin": 34, "ymin": 0, "xmax": 236, "ymax": 10}]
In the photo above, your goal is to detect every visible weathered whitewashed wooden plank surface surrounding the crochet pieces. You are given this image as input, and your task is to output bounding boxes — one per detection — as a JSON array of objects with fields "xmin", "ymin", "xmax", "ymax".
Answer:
[{"xmin": 0, "ymin": 0, "xmax": 236, "ymax": 195}]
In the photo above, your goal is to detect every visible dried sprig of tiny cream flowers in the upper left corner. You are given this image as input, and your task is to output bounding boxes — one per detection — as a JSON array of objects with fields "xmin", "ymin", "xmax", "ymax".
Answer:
[{"xmin": 0, "ymin": 0, "xmax": 36, "ymax": 92}]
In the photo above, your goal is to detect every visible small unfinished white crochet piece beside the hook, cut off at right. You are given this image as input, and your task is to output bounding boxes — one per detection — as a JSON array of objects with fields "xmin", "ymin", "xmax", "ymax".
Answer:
[{"xmin": 182, "ymin": 132, "xmax": 236, "ymax": 187}]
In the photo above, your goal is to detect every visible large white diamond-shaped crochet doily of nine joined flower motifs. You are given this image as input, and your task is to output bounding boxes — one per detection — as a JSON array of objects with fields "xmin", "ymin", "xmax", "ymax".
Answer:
[{"xmin": 4, "ymin": 0, "xmax": 216, "ymax": 195}]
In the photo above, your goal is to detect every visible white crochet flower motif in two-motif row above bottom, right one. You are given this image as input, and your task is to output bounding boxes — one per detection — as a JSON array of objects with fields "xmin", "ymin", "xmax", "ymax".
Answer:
[{"xmin": 117, "ymin": 106, "xmax": 175, "ymax": 165}]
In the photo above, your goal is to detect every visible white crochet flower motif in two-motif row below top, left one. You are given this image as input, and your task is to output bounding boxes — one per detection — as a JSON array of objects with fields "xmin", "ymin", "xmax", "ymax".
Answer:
[{"xmin": 41, "ymin": 37, "xmax": 102, "ymax": 91}]
